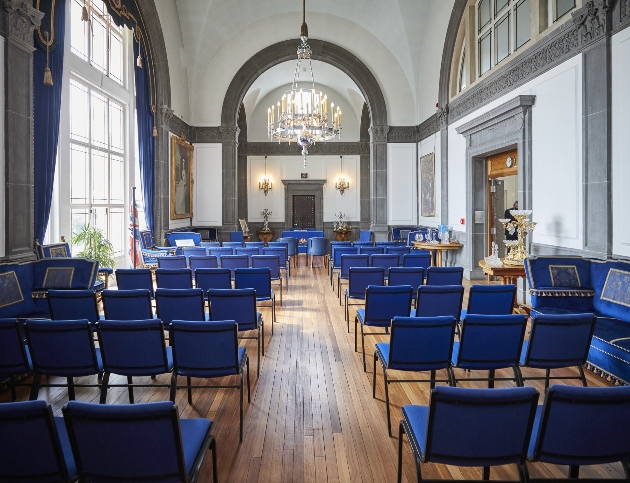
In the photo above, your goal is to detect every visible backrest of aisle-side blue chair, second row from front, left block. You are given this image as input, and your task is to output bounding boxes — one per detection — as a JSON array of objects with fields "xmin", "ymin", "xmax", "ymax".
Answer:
[{"xmin": 169, "ymin": 320, "xmax": 239, "ymax": 377}]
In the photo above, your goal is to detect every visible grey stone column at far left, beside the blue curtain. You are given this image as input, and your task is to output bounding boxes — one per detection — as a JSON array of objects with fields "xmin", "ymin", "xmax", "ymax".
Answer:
[{"xmin": 2, "ymin": 0, "xmax": 44, "ymax": 261}]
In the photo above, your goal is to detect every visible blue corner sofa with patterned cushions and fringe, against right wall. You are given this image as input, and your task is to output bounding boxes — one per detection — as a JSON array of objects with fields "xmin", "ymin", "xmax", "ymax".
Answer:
[{"xmin": 525, "ymin": 256, "xmax": 630, "ymax": 384}]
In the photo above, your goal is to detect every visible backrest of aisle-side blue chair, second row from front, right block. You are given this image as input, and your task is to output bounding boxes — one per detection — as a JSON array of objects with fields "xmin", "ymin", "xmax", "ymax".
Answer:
[{"xmin": 387, "ymin": 315, "xmax": 457, "ymax": 371}]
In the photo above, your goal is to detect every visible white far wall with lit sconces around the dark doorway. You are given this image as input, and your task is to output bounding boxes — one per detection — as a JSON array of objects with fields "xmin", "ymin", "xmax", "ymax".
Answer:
[{"xmin": 247, "ymin": 157, "xmax": 361, "ymax": 227}]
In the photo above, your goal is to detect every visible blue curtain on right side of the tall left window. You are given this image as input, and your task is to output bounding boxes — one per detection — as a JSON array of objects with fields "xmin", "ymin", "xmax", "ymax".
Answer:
[{"xmin": 133, "ymin": 39, "xmax": 155, "ymax": 233}]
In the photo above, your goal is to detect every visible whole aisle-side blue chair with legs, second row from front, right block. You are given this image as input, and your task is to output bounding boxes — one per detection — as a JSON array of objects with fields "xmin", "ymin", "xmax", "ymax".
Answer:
[{"xmin": 372, "ymin": 315, "xmax": 457, "ymax": 437}]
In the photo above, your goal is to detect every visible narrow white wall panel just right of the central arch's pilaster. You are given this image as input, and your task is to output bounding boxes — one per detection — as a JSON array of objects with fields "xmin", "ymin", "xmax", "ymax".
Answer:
[{"xmin": 387, "ymin": 143, "xmax": 418, "ymax": 225}]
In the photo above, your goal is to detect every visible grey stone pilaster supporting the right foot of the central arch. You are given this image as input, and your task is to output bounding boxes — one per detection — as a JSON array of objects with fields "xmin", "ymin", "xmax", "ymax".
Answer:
[{"xmin": 370, "ymin": 126, "xmax": 389, "ymax": 241}]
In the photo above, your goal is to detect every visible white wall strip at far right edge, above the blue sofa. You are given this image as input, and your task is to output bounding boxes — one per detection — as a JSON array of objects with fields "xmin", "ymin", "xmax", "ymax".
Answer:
[{"xmin": 611, "ymin": 29, "xmax": 630, "ymax": 257}]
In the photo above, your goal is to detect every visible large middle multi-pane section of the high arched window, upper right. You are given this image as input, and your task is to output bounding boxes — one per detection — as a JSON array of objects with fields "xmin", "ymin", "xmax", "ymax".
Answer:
[{"xmin": 476, "ymin": 0, "xmax": 531, "ymax": 77}]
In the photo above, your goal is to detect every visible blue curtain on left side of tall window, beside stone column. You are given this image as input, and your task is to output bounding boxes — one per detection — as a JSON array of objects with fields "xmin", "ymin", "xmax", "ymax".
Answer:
[{"xmin": 33, "ymin": 1, "xmax": 66, "ymax": 242}]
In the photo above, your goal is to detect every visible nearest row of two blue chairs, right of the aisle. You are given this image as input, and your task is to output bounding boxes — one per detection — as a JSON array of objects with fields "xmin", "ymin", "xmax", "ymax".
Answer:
[{"xmin": 398, "ymin": 385, "xmax": 630, "ymax": 483}]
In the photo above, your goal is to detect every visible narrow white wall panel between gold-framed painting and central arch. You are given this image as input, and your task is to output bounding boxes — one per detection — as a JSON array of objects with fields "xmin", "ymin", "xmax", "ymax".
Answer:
[{"xmin": 193, "ymin": 143, "xmax": 223, "ymax": 226}]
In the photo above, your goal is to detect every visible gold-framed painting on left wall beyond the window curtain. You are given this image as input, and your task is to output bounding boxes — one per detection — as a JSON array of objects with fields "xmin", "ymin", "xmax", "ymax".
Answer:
[{"xmin": 171, "ymin": 136, "xmax": 194, "ymax": 220}]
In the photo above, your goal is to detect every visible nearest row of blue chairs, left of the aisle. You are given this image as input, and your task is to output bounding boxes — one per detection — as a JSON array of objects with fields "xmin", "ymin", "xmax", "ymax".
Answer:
[{"xmin": 0, "ymin": 401, "xmax": 218, "ymax": 483}]
